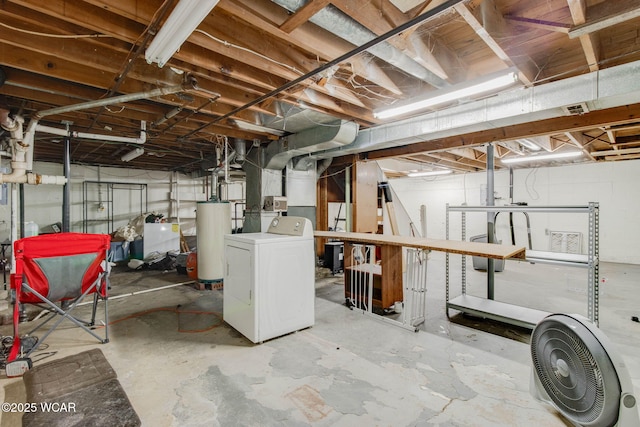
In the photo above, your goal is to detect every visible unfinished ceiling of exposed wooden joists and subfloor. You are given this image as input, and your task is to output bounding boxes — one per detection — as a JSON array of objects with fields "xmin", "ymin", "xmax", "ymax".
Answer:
[{"xmin": 0, "ymin": 0, "xmax": 640, "ymax": 172}]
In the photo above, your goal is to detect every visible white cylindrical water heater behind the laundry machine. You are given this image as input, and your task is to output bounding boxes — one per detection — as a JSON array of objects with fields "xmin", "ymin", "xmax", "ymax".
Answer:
[{"xmin": 196, "ymin": 201, "xmax": 231, "ymax": 283}]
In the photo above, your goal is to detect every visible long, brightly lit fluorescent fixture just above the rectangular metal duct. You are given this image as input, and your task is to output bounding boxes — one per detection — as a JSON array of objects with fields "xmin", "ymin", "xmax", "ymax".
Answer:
[{"xmin": 373, "ymin": 71, "xmax": 518, "ymax": 119}]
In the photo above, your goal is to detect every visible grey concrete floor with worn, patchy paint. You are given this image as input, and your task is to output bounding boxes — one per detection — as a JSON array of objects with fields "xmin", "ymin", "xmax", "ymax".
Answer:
[{"xmin": 0, "ymin": 253, "xmax": 640, "ymax": 427}]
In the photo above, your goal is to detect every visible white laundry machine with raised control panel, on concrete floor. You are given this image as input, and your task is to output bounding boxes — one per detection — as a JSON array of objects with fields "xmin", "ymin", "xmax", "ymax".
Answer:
[{"xmin": 223, "ymin": 216, "xmax": 315, "ymax": 343}]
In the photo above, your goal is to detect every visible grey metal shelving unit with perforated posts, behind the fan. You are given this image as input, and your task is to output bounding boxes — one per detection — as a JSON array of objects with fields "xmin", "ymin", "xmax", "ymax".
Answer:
[{"xmin": 446, "ymin": 202, "xmax": 600, "ymax": 328}]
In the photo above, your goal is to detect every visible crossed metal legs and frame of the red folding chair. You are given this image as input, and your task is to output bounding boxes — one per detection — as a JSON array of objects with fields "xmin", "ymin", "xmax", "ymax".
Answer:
[{"xmin": 8, "ymin": 233, "xmax": 110, "ymax": 361}]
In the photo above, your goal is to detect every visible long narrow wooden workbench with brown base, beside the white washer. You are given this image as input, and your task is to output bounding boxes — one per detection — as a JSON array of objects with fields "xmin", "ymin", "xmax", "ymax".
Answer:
[{"xmin": 314, "ymin": 231, "xmax": 525, "ymax": 308}]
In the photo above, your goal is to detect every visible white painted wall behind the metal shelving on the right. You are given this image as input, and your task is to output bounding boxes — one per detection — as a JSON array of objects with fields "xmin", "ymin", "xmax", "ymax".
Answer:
[{"xmin": 390, "ymin": 160, "xmax": 640, "ymax": 264}]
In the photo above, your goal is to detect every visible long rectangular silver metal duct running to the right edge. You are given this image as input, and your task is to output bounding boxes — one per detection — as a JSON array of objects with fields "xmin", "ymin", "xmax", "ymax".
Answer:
[{"xmin": 310, "ymin": 61, "xmax": 640, "ymax": 160}]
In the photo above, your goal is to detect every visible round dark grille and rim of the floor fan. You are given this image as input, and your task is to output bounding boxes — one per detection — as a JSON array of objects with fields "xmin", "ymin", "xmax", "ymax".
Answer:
[{"xmin": 531, "ymin": 315, "xmax": 621, "ymax": 426}]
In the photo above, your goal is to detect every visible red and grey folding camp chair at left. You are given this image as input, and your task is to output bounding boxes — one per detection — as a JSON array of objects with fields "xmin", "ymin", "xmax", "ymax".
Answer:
[{"xmin": 8, "ymin": 233, "xmax": 111, "ymax": 361}]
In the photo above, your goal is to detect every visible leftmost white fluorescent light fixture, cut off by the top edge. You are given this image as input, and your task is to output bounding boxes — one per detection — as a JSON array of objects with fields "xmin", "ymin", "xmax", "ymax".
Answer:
[{"xmin": 144, "ymin": 0, "xmax": 219, "ymax": 68}]
